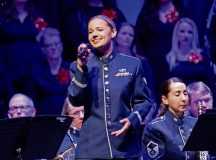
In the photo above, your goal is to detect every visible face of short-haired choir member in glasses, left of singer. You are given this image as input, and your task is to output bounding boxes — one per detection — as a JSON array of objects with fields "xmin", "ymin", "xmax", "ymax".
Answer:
[{"xmin": 42, "ymin": 35, "xmax": 63, "ymax": 60}]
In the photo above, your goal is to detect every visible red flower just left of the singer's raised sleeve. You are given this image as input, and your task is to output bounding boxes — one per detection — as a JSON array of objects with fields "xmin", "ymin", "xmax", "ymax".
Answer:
[{"xmin": 56, "ymin": 68, "xmax": 70, "ymax": 84}]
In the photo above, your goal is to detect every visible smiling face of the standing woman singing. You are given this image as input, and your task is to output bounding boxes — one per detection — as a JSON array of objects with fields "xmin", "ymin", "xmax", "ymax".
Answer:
[{"xmin": 88, "ymin": 18, "xmax": 116, "ymax": 52}]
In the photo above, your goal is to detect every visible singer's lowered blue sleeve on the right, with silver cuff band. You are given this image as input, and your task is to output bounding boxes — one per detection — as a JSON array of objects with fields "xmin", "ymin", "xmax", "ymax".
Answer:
[{"xmin": 128, "ymin": 61, "xmax": 152, "ymax": 128}]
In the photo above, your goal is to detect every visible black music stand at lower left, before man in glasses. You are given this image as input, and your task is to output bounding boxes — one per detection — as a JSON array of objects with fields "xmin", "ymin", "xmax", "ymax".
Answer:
[{"xmin": 0, "ymin": 116, "xmax": 72, "ymax": 160}]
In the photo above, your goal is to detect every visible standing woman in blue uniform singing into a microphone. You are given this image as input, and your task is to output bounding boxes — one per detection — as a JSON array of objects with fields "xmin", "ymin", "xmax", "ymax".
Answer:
[{"xmin": 68, "ymin": 15, "xmax": 152, "ymax": 159}]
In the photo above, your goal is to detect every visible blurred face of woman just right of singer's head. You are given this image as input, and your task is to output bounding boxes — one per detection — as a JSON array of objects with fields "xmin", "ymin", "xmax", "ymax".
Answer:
[{"xmin": 116, "ymin": 25, "xmax": 134, "ymax": 48}]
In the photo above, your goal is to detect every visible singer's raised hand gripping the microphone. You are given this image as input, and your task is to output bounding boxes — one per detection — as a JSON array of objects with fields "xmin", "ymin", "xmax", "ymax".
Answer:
[{"xmin": 77, "ymin": 43, "xmax": 91, "ymax": 72}]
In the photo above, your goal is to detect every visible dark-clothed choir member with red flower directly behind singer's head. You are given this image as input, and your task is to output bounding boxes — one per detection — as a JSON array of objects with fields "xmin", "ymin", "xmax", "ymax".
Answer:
[{"xmin": 62, "ymin": 0, "xmax": 126, "ymax": 61}]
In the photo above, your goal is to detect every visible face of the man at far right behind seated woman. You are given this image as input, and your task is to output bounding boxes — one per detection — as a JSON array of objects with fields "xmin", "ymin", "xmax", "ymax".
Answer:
[{"xmin": 189, "ymin": 93, "xmax": 213, "ymax": 117}]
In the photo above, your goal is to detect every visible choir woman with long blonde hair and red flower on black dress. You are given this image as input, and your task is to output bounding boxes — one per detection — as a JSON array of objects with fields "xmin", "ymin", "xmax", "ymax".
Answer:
[{"xmin": 166, "ymin": 18, "xmax": 215, "ymax": 105}]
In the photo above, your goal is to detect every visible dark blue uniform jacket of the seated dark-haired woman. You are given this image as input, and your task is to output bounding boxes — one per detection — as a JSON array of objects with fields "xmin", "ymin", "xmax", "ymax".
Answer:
[{"xmin": 143, "ymin": 111, "xmax": 197, "ymax": 160}]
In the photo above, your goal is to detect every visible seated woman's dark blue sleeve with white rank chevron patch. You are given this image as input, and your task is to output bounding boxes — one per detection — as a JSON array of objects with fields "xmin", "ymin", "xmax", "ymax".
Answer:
[{"xmin": 142, "ymin": 123, "xmax": 165, "ymax": 160}]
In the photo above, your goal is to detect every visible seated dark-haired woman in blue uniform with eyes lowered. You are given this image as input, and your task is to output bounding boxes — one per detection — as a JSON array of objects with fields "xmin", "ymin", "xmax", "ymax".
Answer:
[{"xmin": 142, "ymin": 77, "xmax": 196, "ymax": 160}]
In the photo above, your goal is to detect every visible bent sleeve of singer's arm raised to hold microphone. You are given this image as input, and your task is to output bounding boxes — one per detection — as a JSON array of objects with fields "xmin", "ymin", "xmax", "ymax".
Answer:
[{"xmin": 68, "ymin": 62, "xmax": 88, "ymax": 106}]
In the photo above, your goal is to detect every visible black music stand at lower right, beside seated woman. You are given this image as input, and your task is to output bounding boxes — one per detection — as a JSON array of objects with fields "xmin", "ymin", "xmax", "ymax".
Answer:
[{"xmin": 183, "ymin": 112, "xmax": 216, "ymax": 154}]
